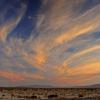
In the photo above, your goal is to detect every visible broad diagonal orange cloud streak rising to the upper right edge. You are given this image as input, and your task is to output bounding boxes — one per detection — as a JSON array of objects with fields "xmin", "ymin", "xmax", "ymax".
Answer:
[{"xmin": 54, "ymin": 5, "xmax": 100, "ymax": 45}]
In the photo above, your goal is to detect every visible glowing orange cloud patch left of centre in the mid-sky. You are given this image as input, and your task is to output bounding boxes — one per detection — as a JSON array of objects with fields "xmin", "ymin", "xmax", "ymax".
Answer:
[{"xmin": 21, "ymin": 41, "xmax": 48, "ymax": 70}]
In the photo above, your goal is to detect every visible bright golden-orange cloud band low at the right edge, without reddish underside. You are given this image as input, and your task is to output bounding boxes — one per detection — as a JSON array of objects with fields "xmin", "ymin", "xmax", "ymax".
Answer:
[{"xmin": 68, "ymin": 62, "xmax": 100, "ymax": 75}]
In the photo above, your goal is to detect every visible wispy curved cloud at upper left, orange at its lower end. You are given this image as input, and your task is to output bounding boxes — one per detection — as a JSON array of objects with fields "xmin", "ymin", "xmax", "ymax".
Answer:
[{"xmin": 0, "ymin": 4, "xmax": 27, "ymax": 41}]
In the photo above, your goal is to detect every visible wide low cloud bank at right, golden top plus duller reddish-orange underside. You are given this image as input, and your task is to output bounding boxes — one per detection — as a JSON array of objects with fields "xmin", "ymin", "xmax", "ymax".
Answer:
[{"xmin": 50, "ymin": 62, "xmax": 100, "ymax": 85}]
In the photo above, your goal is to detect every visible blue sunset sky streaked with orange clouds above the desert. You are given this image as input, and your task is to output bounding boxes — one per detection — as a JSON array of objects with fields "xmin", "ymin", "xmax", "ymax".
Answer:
[{"xmin": 0, "ymin": 0, "xmax": 100, "ymax": 87}]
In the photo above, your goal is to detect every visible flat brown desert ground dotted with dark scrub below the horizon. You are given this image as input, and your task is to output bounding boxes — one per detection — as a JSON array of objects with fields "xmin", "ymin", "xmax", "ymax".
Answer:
[{"xmin": 0, "ymin": 88, "xmax": 100, "ymax": 100}]
